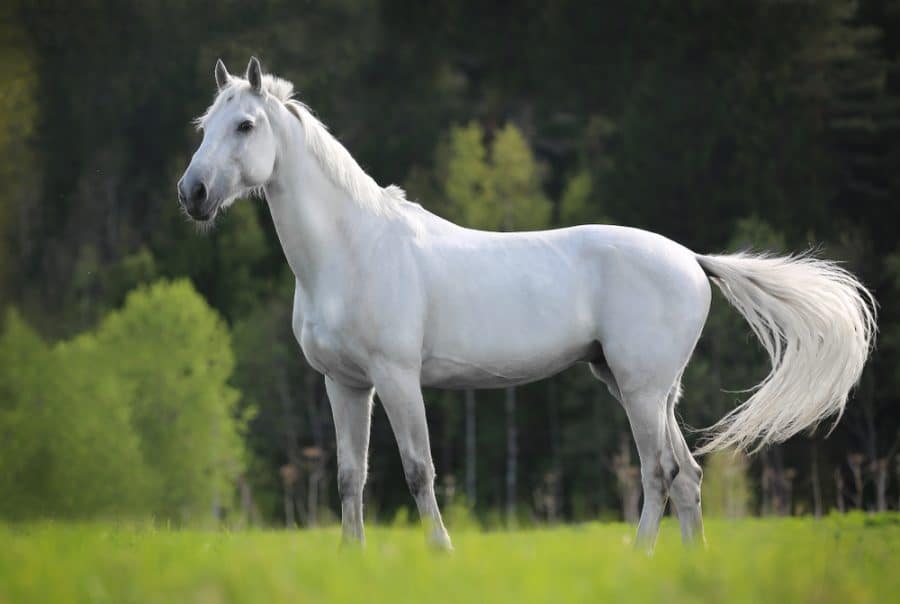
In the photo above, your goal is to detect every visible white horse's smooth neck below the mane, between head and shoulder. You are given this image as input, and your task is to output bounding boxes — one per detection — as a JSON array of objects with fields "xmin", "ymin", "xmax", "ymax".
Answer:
[{"xmin": 265, "ymin": 116, "xmax": 383, "ymax": 292}]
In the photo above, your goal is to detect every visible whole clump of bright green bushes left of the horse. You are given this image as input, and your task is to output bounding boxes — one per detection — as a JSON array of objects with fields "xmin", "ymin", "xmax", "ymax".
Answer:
[{"xmin": 0, "ymin": 281, "xmax": 244, "ymax": 520}]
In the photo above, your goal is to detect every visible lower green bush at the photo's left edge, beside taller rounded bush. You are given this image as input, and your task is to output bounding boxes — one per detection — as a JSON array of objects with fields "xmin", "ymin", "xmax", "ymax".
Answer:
[{"xmin": 0, "ymin": 312, "xmax": 152, "ymax": 518}]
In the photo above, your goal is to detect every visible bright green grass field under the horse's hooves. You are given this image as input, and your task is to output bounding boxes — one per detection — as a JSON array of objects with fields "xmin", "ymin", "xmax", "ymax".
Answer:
[{"xmin": 0, "ymin": 514, "xmax": 900, "ymax": 604}]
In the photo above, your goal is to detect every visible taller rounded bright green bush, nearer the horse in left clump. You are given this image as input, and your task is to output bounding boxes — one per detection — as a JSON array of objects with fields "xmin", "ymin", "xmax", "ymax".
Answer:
[{"xmin": 97, "ymin": 281, "xmax": 244, "ymax": 518}]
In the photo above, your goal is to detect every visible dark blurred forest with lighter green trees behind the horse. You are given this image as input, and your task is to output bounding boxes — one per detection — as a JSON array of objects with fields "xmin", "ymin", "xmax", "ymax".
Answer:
[{"xmin": 0, "ymin": 0, "xmax": 900, "ymax": 525}]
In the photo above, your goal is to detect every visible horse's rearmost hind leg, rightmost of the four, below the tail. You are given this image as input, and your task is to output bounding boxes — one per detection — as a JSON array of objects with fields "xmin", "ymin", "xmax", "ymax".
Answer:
[{"xmin": 666, "ymin": 380, "xmax": 706, "ymax": 544}]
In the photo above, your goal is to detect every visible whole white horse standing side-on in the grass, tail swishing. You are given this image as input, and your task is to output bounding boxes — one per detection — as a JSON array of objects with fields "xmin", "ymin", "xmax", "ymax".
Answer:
[{"xmin": 178, "ymin": 58, "xmax": 875, "ymax": 548}]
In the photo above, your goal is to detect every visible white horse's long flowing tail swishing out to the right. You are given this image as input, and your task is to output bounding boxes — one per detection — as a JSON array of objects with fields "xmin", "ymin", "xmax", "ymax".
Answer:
[{"xmin": 697, "ymin": 253, "xmax": 877, "ymax": 454}]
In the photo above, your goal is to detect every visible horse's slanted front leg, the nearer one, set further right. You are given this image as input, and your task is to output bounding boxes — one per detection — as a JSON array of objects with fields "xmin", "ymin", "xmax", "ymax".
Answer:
[{"xmin": 372, "ymin": 366, "xmax": 453, "ymax": 550}]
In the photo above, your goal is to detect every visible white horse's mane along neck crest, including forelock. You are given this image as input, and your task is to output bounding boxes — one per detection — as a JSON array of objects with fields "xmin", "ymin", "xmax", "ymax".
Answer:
[{"xmin": 196, "ymin": 74, "xmax": 406, "ymax": 216}]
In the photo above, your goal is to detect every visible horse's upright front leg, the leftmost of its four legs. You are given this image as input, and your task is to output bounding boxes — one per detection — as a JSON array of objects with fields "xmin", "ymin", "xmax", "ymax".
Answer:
[{"xmin": 325, "ymin": 377, "xmax": 373, "ymax": 544}]
